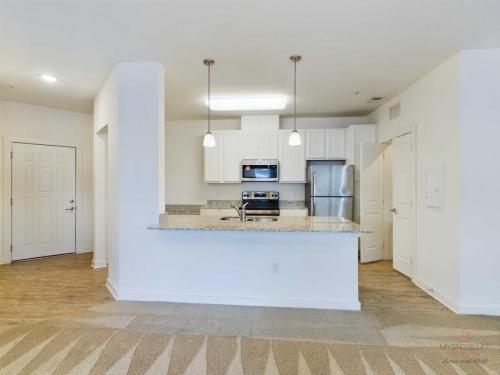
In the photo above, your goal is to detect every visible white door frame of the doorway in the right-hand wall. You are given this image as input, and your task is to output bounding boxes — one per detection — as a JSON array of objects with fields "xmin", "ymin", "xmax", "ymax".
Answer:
[{"xmin": 391, "ymin": 129, "xmax": 418, "ymax": 282}]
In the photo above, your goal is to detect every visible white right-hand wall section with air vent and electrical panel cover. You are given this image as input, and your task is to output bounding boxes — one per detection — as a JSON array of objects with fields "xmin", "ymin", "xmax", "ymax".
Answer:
[{"xmin": 368, "ymin": 56, "xmax": 460, "ymax": 306}]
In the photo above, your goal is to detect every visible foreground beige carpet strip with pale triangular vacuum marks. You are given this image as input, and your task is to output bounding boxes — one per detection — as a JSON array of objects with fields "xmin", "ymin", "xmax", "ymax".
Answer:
[{"xmin": 0, "ymin": 324, "xmax": 500, "ymax": 375}]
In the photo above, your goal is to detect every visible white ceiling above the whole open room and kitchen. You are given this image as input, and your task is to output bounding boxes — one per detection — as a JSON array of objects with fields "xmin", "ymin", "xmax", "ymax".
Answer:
[{"xmin": 0, "ymin": 0, "xmax": 500, "ymax": 120}]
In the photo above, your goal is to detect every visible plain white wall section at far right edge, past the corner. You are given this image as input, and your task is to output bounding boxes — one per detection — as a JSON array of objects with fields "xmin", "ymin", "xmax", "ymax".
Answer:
[{"xmin": 459, "ymin": 49, "xmax": 500, "ymax": 315}]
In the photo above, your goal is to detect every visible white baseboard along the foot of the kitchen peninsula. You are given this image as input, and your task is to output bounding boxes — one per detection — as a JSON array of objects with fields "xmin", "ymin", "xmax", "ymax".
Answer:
[{"xmin": 106, "ymin": 288, "xmax": 361, "ymax": 311}]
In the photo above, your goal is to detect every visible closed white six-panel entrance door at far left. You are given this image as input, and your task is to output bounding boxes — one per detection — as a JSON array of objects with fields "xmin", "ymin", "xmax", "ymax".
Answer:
[{"xmin": 12, "ymin": 143, "xmax": 76, "ymax": 260}]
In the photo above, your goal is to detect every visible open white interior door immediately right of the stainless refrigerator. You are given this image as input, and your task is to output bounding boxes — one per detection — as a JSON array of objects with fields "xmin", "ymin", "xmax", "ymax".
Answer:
[{"xmin": 360, "ymin": 143, "xmax": 386, "ymax": 263}]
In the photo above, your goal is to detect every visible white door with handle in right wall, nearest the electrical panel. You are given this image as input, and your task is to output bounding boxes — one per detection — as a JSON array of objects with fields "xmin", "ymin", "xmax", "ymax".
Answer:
[{"xmin": 392, "ymin": 134, "xmax": 415, "ymax": 277}]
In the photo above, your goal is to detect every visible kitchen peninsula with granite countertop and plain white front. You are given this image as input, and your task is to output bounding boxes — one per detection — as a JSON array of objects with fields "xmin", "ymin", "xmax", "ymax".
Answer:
[{"xmin": 135, "ymin": 215, "xmax": 361, "ymax": 310}]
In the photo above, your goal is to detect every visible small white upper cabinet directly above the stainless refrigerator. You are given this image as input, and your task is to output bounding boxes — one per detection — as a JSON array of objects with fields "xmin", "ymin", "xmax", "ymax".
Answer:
[{"xmin": 306, "ymin": 129, "xmax": 346, "ymax": 160}]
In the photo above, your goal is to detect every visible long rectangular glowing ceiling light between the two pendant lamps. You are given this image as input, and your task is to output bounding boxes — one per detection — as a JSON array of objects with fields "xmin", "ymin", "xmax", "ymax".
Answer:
[{"xmin": 207, "ymin": 95, "xmax": 287, "ymax": 111}]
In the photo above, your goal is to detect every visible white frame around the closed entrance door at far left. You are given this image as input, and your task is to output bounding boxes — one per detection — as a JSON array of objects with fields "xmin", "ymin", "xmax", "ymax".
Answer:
[{"xmin": 0, "ymin": 136, "xmax": 84, "ymax": 264}]
